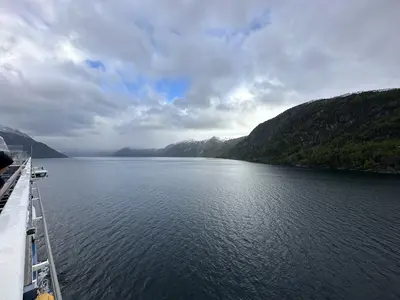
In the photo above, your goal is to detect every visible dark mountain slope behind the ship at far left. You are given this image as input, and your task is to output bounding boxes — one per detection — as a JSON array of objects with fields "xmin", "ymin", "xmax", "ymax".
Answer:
[{"xmin": 0, "ymin": 126, "xmax": 67, "ymax": 158}]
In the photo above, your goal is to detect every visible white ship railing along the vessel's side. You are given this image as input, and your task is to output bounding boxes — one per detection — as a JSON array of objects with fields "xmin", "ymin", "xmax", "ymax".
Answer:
[{"xmin": 0, "ymin": 158, "xmax": 62, "ymax": 300}]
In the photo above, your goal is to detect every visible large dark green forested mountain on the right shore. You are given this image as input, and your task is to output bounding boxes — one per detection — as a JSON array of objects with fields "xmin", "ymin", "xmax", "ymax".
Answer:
[{"xmin": 220, "ymin": 89, "xmax": 400, "ymax": 173}]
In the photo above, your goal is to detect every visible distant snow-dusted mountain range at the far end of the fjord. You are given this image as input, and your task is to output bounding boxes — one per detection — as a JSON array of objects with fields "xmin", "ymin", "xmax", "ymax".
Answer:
[{"xmin": 114, "ymin": 137, "xmax": 243, "ymax": 157}]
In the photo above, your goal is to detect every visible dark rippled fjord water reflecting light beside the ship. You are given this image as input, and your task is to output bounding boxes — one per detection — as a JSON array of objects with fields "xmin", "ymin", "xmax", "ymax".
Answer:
[{"xmin": 35, "ymin": 158, "xmax": 400, "ymax": 300}]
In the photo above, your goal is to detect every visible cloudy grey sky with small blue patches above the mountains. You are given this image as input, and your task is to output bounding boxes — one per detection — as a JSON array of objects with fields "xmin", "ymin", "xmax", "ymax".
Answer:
[{"xmin": 0, "ymin": 0, "xmax": 400, "ymax": 150}]
